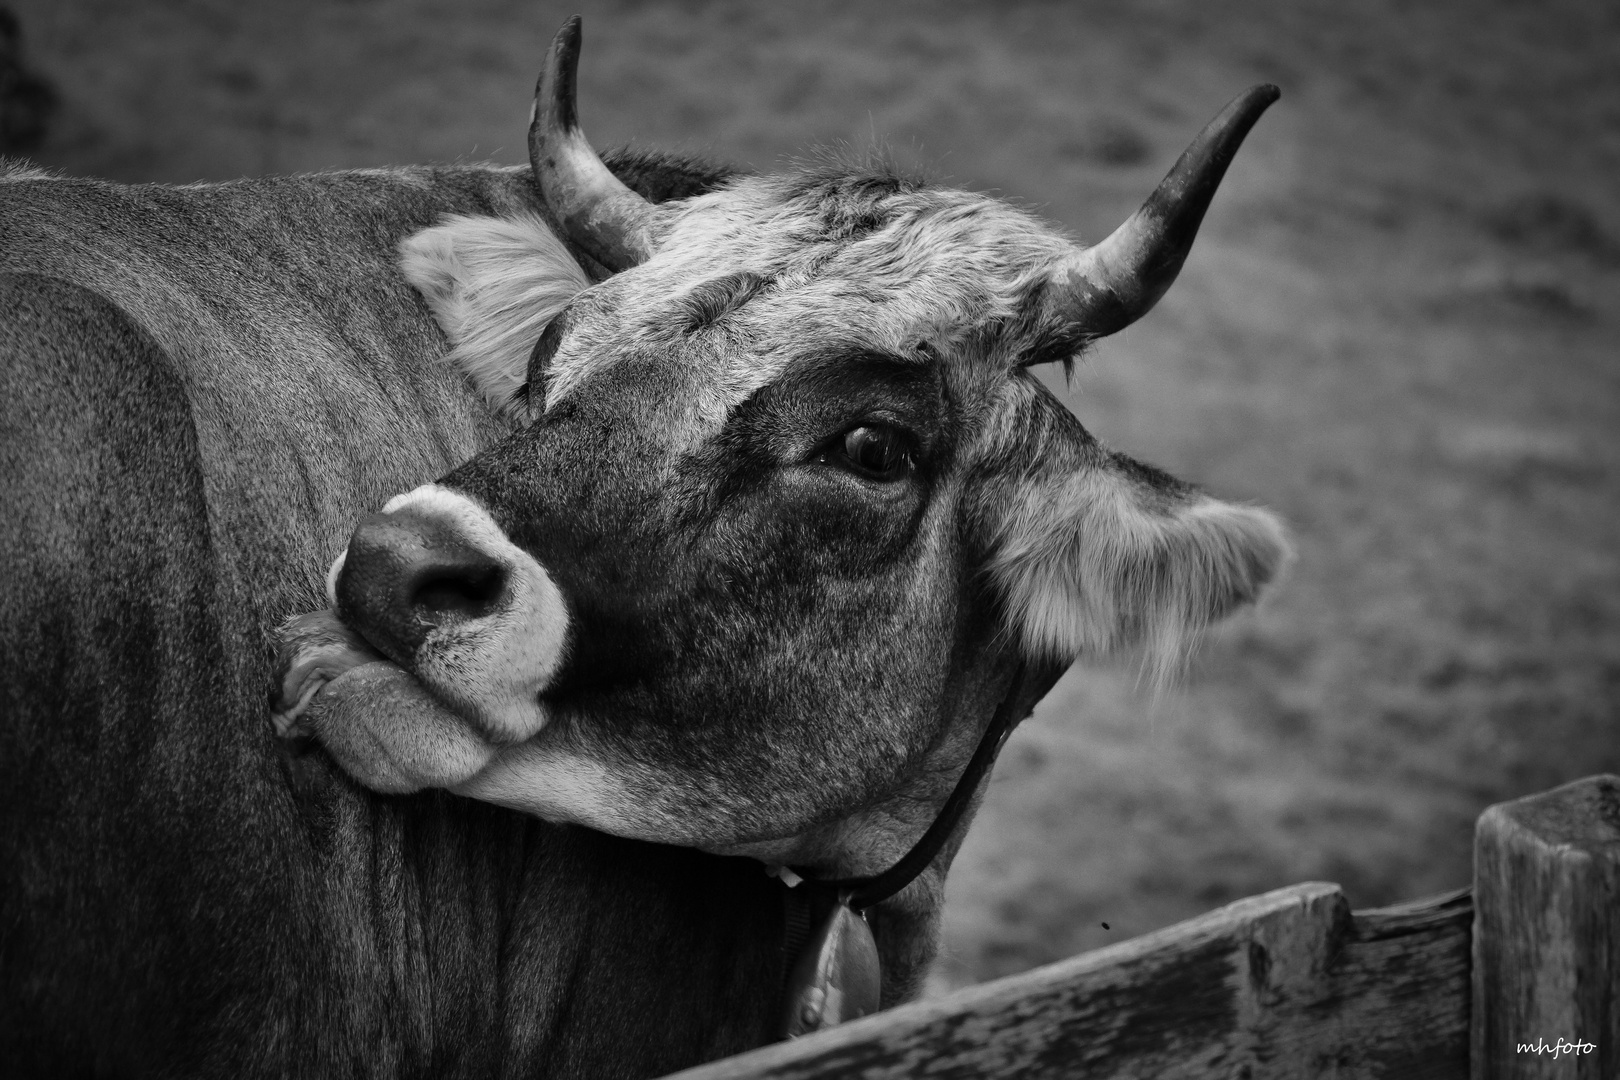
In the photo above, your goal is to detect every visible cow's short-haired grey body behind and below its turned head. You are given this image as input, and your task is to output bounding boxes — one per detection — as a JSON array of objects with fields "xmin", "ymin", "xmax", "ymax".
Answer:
[{"xmin": 0, "ymin": 168, "xmax": 781, "ymax": 1075}]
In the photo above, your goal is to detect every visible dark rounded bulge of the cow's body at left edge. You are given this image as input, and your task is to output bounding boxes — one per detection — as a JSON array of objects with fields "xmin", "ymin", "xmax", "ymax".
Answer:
[{"xmin": 0, "ymin": 274, "xmax": 285, "ymax": 1075}]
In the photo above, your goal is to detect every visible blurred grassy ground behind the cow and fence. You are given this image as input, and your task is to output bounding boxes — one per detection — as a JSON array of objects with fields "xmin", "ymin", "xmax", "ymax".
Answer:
[{"xmin": 6, "ymin": 0, "xmax": 1620, "ymax": 989}]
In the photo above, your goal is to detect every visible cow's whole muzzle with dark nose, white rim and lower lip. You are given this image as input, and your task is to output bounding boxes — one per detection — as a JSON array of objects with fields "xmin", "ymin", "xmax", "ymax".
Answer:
[{"xmin": 271, "ymin": 484, "xmax": 569, "ymax": 792}]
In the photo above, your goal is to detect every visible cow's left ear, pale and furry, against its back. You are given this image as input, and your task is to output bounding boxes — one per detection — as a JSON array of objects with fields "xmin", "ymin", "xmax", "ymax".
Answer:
[{"xmin": 400, "ymin": 214, "xmax": 590, "ymax": 419}]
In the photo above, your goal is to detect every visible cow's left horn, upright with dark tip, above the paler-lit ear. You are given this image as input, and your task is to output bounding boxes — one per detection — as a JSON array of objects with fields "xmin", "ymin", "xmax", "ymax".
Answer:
[{"xmin": 528, "ymin": 15, "xmax": 653, "ymax": 270}]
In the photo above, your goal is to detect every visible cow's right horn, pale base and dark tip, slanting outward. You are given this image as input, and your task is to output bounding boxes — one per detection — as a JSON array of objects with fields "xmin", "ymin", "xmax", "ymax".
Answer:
[{"xmin": 1048, "ymin": 84, "xmax": 1281, "ymax": 346}]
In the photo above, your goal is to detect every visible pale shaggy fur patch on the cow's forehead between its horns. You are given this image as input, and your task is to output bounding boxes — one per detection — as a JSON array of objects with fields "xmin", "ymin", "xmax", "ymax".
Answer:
[{"xmin": 548, "ymin": 172, "xmax": 1072, "ymax": 423}]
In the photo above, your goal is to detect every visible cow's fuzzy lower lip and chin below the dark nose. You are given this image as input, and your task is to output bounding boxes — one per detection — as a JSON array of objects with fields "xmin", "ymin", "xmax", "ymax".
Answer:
[{"xmin": 303, "ymin": 661, "xmax": 496, "ymax": 795}]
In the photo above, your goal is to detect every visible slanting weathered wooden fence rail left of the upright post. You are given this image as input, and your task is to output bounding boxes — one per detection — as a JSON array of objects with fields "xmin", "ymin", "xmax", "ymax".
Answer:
[{"xmin": 676, "ymin": 884, "xmax": 1473, "ymax": 1080}]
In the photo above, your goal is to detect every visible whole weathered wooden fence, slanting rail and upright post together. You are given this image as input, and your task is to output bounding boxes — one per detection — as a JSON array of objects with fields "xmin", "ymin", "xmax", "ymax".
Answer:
[{"xmin": 672, "ymin": 776, "xmax": 1620, "ymax": 1080}]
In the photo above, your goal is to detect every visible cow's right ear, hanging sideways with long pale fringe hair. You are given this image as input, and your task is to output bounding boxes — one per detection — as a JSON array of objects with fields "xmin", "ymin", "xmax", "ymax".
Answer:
[{"xmin": 990, "ymin": 463, "xmax": 1291, "ymax": 682}]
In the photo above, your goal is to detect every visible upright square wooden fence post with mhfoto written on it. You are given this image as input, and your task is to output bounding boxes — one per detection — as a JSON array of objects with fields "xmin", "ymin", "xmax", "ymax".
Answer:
[{"xmin": 1471, "ymin": 776, "xmax": 1620, "ymax": 1080}]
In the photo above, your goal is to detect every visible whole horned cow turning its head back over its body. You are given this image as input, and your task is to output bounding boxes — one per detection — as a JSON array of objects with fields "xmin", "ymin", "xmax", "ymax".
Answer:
[{"xmin": 0, "ymin": 19, "xmax": 1288, "ymax": 1077}]
